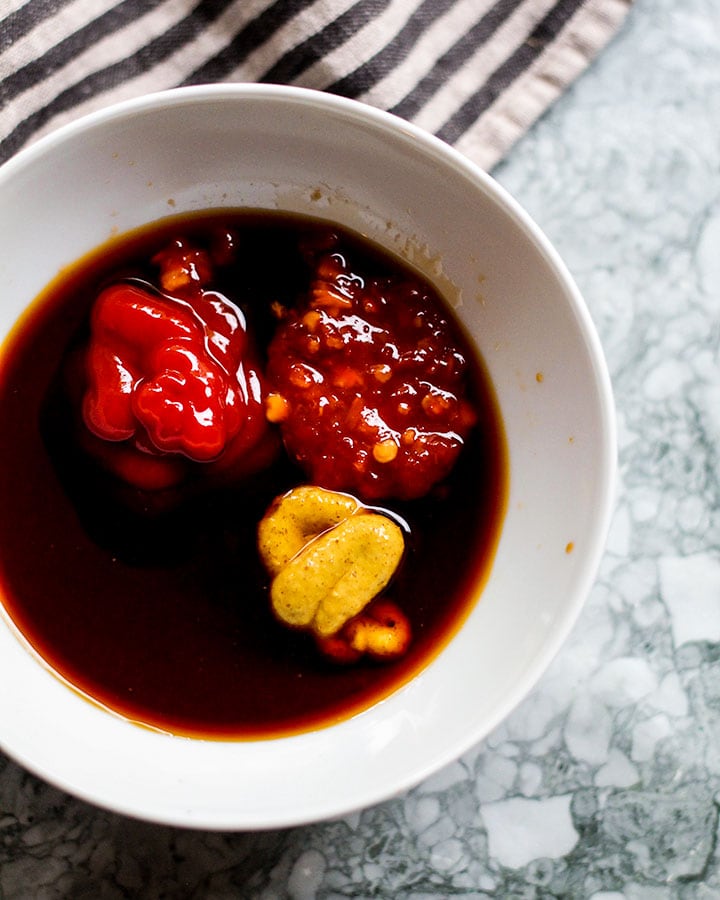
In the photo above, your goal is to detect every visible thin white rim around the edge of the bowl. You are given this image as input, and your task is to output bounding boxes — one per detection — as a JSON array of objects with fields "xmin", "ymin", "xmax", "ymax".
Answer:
[{"xmin": 0, "ymin": 83, "xmax": 617, "ymax": 830}]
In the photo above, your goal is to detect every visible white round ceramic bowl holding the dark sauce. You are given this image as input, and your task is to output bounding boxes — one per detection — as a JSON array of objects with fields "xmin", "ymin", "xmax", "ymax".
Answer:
[{"xmin": 0, "ymin": 85, "xmax": 615, "ymax": 829}]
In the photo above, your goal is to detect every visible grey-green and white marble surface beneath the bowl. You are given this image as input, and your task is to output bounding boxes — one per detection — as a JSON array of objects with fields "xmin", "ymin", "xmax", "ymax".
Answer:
[{"xmin": 0, "ymin": 0, "xmax": 720, "ymax": 900}]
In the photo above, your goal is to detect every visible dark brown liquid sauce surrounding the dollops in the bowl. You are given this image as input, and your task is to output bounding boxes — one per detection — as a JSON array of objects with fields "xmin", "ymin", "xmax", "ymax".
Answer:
[{"xmin": 0, "ymin": 212, "xmax": 507, "ymax": 738}]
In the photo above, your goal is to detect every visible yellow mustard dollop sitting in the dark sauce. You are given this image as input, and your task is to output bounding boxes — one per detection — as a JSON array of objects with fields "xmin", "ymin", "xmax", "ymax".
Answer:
[{"xmin": 258, "ymin": 486, "xmax": 405, "ymax": 644}]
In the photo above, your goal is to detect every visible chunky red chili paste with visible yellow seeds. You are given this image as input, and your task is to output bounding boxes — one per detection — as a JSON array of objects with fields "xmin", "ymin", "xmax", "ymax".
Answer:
[{"xmin": 267, "ymin": 234, "xmax": 477, "ymax": 500}]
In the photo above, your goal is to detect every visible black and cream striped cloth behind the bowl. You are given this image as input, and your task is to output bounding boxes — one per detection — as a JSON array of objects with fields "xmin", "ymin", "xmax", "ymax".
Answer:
[{"xmin": 0, "ymin": 0, "xmax": 632, "ymax": 168}]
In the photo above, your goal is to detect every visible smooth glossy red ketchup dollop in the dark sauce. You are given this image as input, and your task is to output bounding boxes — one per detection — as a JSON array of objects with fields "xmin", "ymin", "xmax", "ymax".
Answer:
[{"xmin": 82, "ymin": 240, "xmax": 276, "ymax": 490}]
